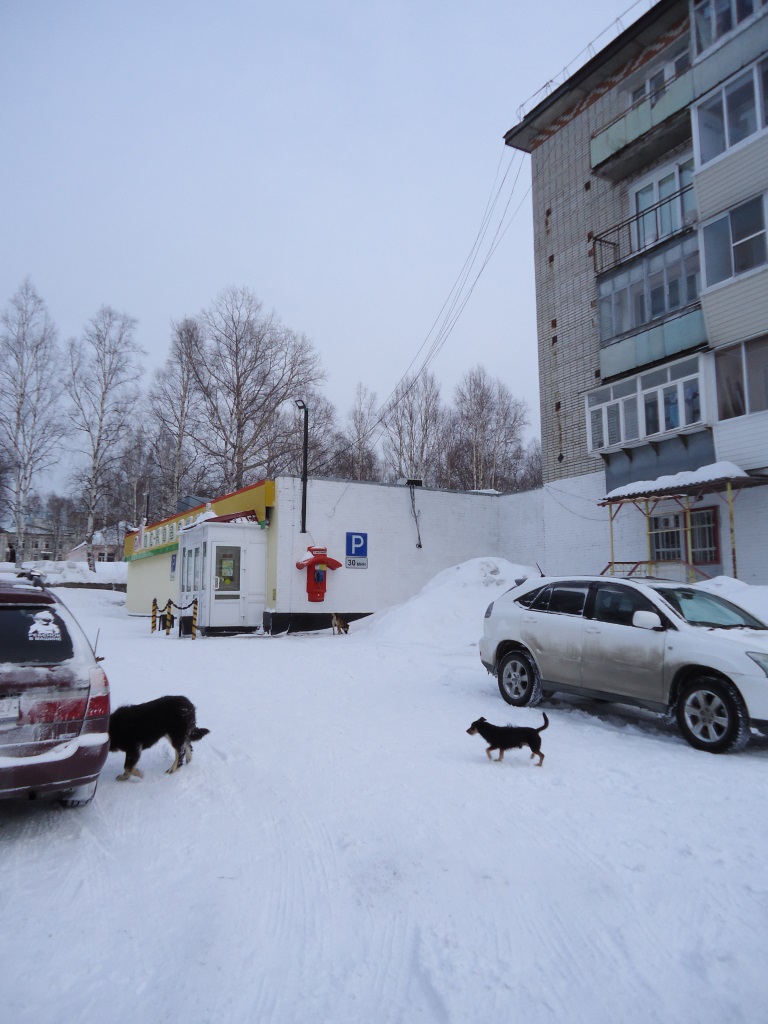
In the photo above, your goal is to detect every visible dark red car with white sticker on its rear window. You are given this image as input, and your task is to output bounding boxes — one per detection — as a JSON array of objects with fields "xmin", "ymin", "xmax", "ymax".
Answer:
[{"xmin": 0, "ymin": 574, "xmax": 110, "ymax": 807}]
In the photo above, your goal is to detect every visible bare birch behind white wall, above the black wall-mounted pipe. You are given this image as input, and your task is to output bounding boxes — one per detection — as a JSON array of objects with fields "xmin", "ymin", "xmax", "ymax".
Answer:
[{"xmin": 384, "ymin": 373, "xmax": 443, "ymax": 483}]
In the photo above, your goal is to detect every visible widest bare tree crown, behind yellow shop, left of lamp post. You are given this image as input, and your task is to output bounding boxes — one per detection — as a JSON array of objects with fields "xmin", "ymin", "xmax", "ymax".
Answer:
[{"xmin": 188, "ymin": 288, "xmax": 325, "ymax": 490}]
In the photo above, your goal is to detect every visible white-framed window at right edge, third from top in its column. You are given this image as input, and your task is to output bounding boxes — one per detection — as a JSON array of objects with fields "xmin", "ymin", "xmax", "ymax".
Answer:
[{"xmin": 702, "ymin": 196, "xmax": 768, "ymax": 287}]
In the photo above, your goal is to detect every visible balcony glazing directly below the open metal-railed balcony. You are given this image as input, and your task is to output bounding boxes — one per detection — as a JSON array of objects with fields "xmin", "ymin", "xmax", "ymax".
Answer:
[{"xmin": 597, "ymin": 236, "xmax": 698, "ymax": 345}]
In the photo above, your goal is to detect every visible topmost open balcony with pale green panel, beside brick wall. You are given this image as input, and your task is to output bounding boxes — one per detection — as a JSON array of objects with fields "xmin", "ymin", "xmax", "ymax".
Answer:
[{"xmin": 590, "ymin": 69, "xmax": 693, "ymax": 181}]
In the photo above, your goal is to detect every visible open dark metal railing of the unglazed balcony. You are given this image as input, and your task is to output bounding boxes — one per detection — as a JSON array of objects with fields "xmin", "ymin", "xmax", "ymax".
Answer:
[{"xmin": 592, "ymin": 184, "xmax": 696, "ymax": 274}]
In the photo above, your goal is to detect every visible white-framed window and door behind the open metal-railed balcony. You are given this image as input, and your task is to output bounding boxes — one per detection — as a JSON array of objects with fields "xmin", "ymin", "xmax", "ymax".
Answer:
[{"xmin": 631, "ymin": 157, "xmax": 696, "ymax": 249}]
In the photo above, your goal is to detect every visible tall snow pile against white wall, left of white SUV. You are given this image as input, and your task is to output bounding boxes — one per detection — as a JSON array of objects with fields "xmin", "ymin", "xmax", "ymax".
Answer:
[{"xmin": 353, "ymin": 557, "xmax": 538, "ymax": 648}]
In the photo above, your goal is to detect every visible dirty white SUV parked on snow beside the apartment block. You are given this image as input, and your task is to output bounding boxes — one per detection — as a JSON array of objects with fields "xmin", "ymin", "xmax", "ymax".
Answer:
[{"xmin": 480, "ymin": 577, "xmax": 768, "ymax": 754}]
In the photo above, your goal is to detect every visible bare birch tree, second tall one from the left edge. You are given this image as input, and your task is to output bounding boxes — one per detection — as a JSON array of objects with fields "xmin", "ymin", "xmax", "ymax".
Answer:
[{"xmin": 67, "ymin": 306, "xmax": 142, "ymax": 569}]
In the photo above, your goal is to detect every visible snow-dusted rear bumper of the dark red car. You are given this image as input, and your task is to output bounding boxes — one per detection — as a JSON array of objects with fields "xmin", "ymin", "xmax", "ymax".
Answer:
[{"xmin": 0, "ymin": 732, "xmax": 110, "ymax": 800}]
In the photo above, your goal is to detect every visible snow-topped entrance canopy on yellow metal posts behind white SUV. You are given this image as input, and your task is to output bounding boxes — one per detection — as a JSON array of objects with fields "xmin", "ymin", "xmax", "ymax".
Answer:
[{"xmin": 597, "ymin": 463, "xmax": 768, "ymax": 583}]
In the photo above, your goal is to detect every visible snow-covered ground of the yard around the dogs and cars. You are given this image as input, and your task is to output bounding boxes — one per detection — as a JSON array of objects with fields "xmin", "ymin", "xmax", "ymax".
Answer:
[{"xmin": 0, "ymin": 558, "xmax": 768, "ymax": 1024}]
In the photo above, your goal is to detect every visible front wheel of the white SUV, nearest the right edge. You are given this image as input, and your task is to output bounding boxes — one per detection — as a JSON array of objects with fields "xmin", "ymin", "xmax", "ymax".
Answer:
[{"xmin": 677, "ymin": 676, "xmax": 750, "ymax": 754}]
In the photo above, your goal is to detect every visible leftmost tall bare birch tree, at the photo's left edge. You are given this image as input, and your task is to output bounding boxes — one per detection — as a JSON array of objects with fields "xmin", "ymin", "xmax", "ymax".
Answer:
[{"xmin": 0, "ymin": 279, "xmax": 68, "ymax": 565}]
